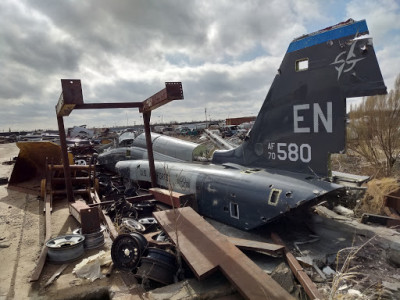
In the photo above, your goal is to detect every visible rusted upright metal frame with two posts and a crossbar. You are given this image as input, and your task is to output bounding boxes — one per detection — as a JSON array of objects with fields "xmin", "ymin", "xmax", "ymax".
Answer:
[{"xmin": 56, "ymin": 79, "xmax": 183, "ymax": 202}]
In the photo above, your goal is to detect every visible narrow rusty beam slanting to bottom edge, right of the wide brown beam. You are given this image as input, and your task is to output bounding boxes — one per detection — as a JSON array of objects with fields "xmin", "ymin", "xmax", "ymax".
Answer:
[{"xmin": 271, "ymin": 232, "xmax": 323, "ymax": 299}]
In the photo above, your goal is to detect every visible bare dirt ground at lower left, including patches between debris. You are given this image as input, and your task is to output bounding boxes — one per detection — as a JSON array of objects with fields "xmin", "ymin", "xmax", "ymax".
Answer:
[{"xmin": 0, "ymin": 144, "xmax": 135, "ymax": 300}]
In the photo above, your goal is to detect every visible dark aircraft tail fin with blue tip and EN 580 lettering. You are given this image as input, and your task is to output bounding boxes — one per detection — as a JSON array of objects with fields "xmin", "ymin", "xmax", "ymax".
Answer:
[{"xmin": 213, "ymin": 19, "xmax": 386, "ymax": 176}]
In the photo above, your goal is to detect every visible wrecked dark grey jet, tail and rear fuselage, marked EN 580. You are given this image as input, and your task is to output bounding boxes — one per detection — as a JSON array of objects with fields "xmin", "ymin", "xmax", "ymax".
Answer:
[{"xmin": 116, "ymin": 20, "xmax": 386, "ymax": 230}]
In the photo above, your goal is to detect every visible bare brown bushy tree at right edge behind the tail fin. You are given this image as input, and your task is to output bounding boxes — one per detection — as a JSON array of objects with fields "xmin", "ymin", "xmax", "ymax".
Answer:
[{"xmin": 347, "ymin": 75, "xmax": 400, "ymax": 177}]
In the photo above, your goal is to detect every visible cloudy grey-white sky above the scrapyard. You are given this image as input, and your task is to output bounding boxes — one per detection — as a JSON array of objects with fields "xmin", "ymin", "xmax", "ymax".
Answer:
[{"xmin": 0, "ymin": 0, "xmax": 400, "ymax": 131}]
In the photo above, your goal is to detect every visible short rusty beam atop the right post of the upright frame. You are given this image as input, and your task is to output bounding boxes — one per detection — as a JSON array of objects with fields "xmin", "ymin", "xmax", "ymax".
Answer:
[{"xmin": 139, "ymin": 82, "xmax": 183, "ymax": 113}]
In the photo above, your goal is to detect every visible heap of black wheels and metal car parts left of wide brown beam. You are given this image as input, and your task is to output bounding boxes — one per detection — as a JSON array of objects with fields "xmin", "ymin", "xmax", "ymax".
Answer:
[{"xmin": 105, "ymin": 191, "xmax": 182, "ymax": 287}]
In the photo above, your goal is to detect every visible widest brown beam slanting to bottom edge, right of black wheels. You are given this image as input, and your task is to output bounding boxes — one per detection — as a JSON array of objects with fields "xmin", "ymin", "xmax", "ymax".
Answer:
[{"xmin": 153, "ymin": 207, "xmax": 293, "ymax": 299}]
